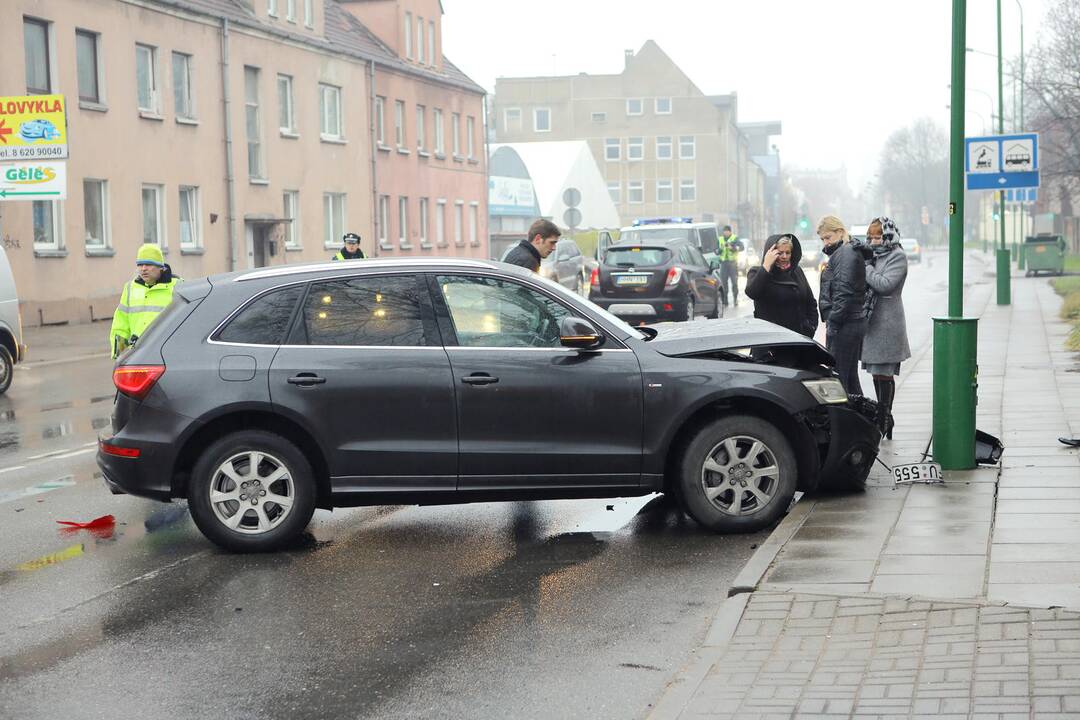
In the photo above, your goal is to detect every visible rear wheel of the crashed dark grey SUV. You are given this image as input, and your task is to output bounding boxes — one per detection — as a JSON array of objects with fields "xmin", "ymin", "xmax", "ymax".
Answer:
[{"xmin": 188, "ymin": 430, "xmax": 316, "ymax": 553}]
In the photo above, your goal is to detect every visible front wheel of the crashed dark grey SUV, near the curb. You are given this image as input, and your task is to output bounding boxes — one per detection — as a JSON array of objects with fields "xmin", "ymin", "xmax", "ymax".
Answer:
[{"xmin": 676, "ymin": 415, "xmax": 797, "ymax": 532}]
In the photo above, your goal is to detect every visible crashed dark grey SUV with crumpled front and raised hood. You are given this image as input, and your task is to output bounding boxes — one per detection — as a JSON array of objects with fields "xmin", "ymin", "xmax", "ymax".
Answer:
[{"xmin": 97, "ymin": 258, "xmax": 879, "ymax": 551}]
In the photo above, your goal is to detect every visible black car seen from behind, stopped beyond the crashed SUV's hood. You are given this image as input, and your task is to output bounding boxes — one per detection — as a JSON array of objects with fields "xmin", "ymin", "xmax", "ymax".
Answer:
[{"xmin": 589, "ymin": 239, "xmax": 724, "ymax": 322}]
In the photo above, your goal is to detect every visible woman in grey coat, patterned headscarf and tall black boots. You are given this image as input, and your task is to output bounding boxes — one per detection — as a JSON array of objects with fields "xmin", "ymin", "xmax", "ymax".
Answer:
[{"xmin": 863, "ymin": 217, "xmax": 912, "ymax": 439}]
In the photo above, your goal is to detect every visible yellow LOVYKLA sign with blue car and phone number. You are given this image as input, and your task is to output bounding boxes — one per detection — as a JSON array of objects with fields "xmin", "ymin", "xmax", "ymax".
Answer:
[{"xmin": 0, "ymin": 95, "xmax": 68, "ymax": 162}]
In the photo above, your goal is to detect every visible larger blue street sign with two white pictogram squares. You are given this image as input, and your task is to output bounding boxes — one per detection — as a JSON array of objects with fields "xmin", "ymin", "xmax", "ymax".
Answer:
[{"xmin": 963, "ymin": 133, "xmax": 1039, "ymax": 190}]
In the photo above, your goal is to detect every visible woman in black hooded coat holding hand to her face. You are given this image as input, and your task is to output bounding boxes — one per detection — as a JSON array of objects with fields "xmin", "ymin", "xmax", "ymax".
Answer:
[{"xmin": 745, "ymin": 233, "xmax": 818, "ymax": 338}]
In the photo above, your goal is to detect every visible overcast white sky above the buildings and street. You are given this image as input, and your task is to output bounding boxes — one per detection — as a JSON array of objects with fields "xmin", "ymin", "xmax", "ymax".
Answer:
[{"xmin": 443, "ymin": 0, "xmax": 1052, "ymax": 190}]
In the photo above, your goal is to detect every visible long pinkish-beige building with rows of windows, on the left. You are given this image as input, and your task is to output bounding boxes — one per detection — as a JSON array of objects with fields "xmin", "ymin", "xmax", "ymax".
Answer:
[{"xmin": 0, "ymin": 0, "xmax": 487, "ymax": 325}]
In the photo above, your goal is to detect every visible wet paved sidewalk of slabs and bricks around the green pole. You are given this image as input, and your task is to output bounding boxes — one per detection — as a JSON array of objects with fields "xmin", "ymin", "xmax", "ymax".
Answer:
[{"xmin": 651, "ymin": 267, "xmax": 1080, "ymax": 720}]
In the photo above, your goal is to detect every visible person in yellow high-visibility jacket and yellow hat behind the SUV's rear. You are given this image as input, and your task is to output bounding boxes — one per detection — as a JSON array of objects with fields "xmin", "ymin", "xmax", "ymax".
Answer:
[{"xmin": 109, "ymin": 243, "xmax": 183, "ymax": 359}]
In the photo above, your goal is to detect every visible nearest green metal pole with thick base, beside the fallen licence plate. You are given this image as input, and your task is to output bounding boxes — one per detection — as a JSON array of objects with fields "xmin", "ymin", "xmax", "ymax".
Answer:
[{"xmin": 933, "ymin": 0, "xmax": 978, "ymax": 470}]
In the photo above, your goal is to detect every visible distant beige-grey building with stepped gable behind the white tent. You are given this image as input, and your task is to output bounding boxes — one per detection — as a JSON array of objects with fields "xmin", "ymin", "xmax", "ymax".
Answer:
[{"xmin": 491, "ymin": 40, "xmax": 766, "ymax": 232}]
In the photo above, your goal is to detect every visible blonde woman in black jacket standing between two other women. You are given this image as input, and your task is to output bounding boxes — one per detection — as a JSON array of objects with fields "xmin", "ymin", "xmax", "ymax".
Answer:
[{"xmin": 818, "ymin": 215, "xmax": 868, "ymax": 395}]
